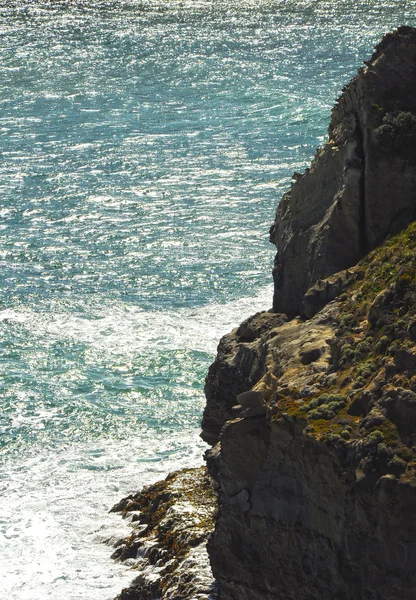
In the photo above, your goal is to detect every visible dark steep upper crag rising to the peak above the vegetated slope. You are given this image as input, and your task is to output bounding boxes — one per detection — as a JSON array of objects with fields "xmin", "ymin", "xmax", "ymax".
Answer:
[{"xmin": 271, "ymin": 27, "xmax": 416, "ymax": 315}]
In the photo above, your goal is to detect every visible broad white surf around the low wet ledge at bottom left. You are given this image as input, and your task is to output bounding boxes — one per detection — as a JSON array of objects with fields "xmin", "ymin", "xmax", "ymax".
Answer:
[{"xmin": 0, "ymin": 431, "xmax": 205, "ymax": 600}]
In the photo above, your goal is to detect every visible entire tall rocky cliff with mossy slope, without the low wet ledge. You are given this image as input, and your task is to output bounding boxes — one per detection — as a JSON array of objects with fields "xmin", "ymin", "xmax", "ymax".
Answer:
[{"xmin": 203, "ymin": 28, "xmax": 416, "ymax": 600}]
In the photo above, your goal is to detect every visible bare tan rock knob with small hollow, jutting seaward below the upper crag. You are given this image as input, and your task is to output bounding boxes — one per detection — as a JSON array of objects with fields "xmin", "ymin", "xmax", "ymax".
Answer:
[{"xmin": 202, "ymin": 304, "xmax": 337, "ymax": 444}]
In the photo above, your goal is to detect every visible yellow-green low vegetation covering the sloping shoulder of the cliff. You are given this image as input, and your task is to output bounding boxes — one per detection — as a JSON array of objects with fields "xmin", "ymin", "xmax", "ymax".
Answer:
[{"xmin": 274, "ymin": 223, "xmax": 416, "ymax": 478}]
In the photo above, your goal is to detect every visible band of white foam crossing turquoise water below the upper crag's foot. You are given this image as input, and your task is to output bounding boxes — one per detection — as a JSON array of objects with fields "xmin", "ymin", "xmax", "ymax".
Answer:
[{"xmin": 11, "ymin": 286, "xmax": 272, "ymax": 359}]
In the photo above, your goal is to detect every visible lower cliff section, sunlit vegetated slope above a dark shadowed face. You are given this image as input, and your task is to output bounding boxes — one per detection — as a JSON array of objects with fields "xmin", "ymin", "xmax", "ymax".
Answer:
[{"xmin": 207, "ymin": 223, "xmax": 416, "ymax": 600}]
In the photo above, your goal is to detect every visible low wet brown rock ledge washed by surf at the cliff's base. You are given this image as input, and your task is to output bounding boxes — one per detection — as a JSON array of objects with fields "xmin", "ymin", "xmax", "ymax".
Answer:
[{"xmin": 112, "ymin": 467, "xmax": 217, "ymax": 600}]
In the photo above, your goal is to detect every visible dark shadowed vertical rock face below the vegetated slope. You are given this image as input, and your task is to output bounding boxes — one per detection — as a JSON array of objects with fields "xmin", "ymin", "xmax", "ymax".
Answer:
[{"xmin": 209, "ymin": 419, "xmax": 416, "ymax": 600}]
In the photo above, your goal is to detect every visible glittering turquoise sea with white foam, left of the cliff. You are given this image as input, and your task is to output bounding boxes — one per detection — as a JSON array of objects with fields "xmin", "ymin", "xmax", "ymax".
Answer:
[{"xmin": 0, "ymin": 0, "xmax": 416, "ymax": 600}]
